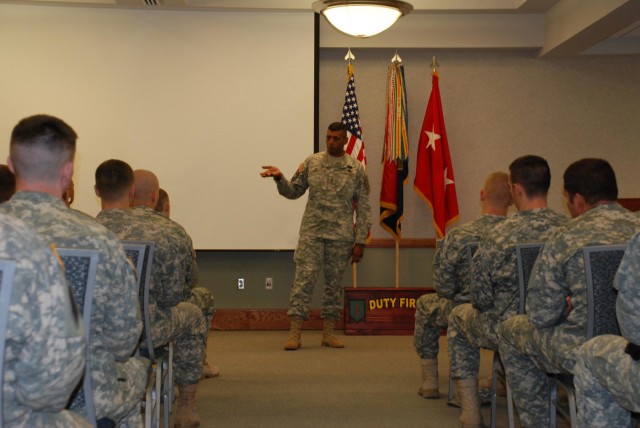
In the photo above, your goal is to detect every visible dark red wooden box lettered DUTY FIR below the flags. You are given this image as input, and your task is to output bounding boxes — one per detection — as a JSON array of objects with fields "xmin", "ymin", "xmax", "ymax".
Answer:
[{"xmin": 343, "ymin": 287, "xmax": 435, "ymax": 335}]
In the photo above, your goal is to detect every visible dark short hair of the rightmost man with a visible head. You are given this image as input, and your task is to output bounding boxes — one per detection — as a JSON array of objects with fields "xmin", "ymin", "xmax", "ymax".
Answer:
[{"xmin": 563, "ymin": 158, "xmax": 618, "ymax": 205}]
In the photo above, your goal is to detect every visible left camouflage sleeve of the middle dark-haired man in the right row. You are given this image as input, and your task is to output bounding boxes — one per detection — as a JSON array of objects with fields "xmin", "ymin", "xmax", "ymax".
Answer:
[{"xmin": 470, "ymin": 239, "xmax": 500, "ymax": 312}]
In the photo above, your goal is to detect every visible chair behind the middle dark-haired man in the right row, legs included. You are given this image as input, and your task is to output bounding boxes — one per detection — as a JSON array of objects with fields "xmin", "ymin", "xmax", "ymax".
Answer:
[{"xmin": 491, "ymin": 242, "xmax": 544, "ymax": 428}]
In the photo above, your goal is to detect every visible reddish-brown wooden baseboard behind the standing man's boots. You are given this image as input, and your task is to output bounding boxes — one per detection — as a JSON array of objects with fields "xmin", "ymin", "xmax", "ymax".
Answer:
[{"xmin": 211, "ymin": 309, "xmax": 344, "ymax": 330}]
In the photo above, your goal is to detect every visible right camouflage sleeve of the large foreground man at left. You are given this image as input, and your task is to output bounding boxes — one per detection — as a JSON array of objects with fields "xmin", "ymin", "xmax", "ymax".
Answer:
[{"xmin": 99, "ymin": 240, "xmax": 142, "ymax": 359}]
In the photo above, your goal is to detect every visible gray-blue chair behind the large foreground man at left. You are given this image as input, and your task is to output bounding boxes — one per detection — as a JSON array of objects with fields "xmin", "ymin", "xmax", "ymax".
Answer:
[{"xmin": 57, "ymin": 248, "xmax": 99, "ymax": 427}]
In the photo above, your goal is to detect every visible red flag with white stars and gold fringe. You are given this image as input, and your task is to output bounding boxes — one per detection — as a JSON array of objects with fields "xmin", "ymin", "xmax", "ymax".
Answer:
[{"xmin": 413, "ymin": 71, "xmax": 459, "ymax": 238}]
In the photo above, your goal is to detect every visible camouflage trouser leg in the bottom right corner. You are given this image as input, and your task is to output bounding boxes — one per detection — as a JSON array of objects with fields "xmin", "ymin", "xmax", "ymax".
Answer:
[{"xmin": 573, "ymin": 335, "xmax": 640, "ymax": 428}]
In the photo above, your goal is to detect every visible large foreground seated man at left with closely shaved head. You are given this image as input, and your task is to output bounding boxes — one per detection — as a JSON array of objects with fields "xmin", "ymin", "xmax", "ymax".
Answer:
[{"xmin": 0, "ymin": 115, "xmax": 149, "ymax": 426}]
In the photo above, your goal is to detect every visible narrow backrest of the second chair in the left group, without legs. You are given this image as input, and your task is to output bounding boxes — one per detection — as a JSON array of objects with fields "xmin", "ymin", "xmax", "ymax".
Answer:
[{"xmin": 122, "ymin": 240, "xmax": 156, "ymax": 361}]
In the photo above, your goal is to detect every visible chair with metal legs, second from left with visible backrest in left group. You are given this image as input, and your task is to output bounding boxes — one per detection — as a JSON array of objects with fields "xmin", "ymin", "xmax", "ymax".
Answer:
[{"xmin": 122, "ymin": 241, "xmax": 173, "ymax": 428}]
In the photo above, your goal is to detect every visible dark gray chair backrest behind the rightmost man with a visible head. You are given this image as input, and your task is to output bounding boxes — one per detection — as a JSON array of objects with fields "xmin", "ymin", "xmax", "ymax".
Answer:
[{"xmin": 582, "ymin": 244, "xmax": 627, "ymax": 339}]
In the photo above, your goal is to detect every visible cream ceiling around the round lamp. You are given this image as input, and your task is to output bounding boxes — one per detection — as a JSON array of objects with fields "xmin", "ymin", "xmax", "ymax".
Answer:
[{"xmin": 0, "ymin": 0, "xmax": 640, "ymax": 57}]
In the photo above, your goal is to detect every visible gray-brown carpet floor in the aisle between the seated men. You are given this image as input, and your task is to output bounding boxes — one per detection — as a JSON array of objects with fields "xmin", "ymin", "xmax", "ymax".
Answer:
[{"xmin": 190, "ymin": 331, "xmax": 566, "ymax": 428}]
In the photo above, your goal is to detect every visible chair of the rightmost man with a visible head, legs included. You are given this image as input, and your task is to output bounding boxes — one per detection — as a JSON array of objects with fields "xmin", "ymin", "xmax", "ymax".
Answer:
[{"xmin": 549, "ymin": 245, "xmax": 627, "ymax": 428}]
